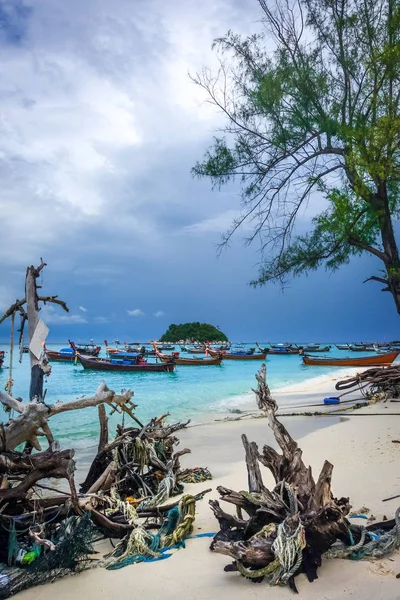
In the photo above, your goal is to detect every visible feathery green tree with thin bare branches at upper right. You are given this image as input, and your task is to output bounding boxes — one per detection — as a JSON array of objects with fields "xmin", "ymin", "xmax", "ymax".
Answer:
[{"xmin": 193, "ymin": 0, "xmax": 400, "ymax": 313}]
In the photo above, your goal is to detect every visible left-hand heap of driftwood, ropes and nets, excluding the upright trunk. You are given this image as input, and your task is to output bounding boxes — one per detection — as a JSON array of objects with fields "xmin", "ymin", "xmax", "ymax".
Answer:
[{"xmin": 0, "ymin": 396, "xmax": 212, "ymax": 598}]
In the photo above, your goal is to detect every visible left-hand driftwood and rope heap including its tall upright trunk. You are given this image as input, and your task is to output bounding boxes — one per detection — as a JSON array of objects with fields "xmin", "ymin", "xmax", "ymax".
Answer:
[{"xmin": 0, "ymin": 261, "xmax": 211, "ymax": 598}]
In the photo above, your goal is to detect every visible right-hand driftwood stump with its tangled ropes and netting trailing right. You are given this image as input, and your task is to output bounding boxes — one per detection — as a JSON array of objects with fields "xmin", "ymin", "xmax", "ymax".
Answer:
[{"xmin": 210, "ymin": 364, "xmax": 400, "ymax": 592}]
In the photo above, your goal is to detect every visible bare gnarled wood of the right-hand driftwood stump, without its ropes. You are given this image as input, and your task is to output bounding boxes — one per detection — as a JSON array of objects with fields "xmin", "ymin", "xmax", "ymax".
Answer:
[{"xmin": 211, "ymin": 365, "xmax": 355, "ymax": 590}]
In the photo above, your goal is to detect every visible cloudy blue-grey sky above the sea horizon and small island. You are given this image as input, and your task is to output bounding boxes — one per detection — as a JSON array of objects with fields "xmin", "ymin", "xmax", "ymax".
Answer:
[{"xmin": 0, "ymin": 0, "xmax": 400, "ymax": 342}]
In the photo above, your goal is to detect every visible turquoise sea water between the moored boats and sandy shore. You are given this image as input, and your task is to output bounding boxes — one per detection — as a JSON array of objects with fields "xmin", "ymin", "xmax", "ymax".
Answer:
[{"xmin": 0, "ymin": 344, "xmax": 368, "ymax": 448}]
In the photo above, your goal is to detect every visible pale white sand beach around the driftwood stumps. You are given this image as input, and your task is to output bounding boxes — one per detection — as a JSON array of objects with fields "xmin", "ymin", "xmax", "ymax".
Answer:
[{"xmin": 19, "ymin": 370, "xmax": 400, "ymax": 600}]
